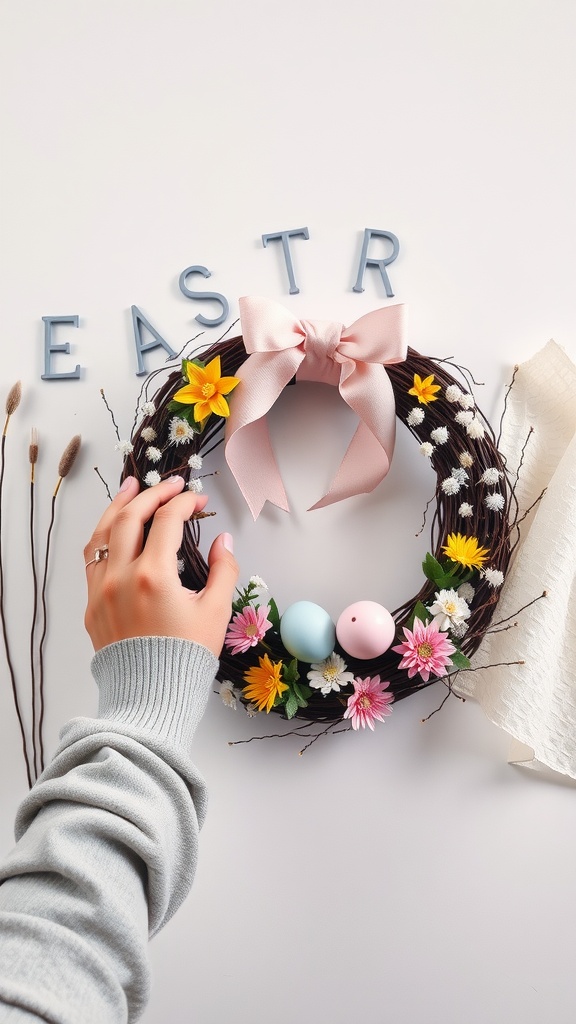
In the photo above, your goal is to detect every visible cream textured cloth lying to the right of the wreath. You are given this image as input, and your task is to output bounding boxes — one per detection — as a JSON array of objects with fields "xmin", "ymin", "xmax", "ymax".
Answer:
[{"xmin": 454, "ymin": 341, "xmax": 576, "ymax": 779}]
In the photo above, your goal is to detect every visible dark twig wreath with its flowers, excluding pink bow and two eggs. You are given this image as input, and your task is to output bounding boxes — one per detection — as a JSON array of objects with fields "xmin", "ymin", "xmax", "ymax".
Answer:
[{"xmin": 117, "ymin": 300, "xmax": 518, "ymax": 741}]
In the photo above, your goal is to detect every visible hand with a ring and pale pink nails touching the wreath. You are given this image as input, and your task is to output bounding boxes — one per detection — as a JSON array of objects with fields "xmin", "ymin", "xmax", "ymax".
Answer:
[{"xmin": 84, "ymin": 476, "xmax": 238, "ymax": 656}]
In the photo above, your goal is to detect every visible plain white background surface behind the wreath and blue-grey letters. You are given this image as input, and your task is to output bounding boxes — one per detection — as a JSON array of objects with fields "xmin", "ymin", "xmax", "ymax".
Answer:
[{"xmin": 0, "ymin": 0, "xmax": 576, "ymax": 1024}]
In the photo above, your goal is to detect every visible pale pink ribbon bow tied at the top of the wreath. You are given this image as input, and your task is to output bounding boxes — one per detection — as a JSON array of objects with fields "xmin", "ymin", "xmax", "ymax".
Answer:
[{"xmin": 225, "ymin": 297, "xmax": 406, "ymax": 519}]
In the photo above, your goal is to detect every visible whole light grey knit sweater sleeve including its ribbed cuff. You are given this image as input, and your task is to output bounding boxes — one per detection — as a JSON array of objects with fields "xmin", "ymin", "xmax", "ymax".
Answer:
[{"xmin": 0, "ymin": 637, "xmax": 217, "ymax": 1024}]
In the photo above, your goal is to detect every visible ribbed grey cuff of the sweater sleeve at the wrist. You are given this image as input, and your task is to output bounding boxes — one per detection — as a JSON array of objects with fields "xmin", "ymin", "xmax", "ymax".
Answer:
[{"xmin": 91, "ymin": 637, "xmax": 218, "ymax": 748}]
